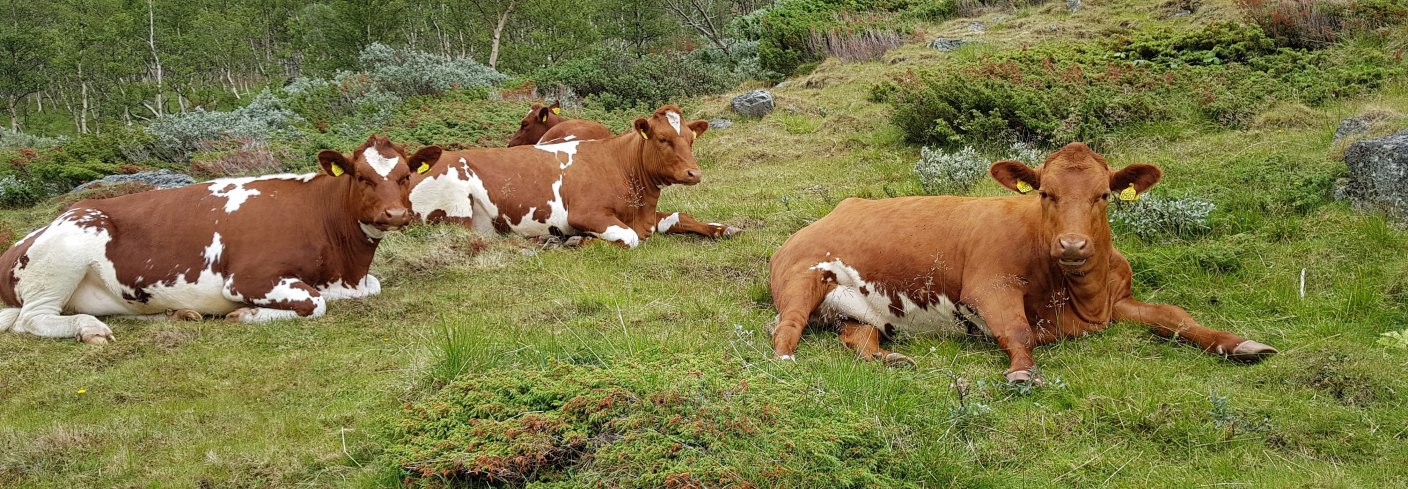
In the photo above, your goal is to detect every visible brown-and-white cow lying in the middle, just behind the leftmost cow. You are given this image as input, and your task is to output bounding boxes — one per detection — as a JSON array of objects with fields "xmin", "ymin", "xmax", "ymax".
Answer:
[{"xmin": 411, "ymin": 106, "xmax": 739, "ymax": 248}]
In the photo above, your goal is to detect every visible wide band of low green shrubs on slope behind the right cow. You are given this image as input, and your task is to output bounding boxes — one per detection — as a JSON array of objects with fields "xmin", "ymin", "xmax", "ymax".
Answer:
[{"xmin": 872, "ymin": 23, "xmax": 1402, "ymax": 147}]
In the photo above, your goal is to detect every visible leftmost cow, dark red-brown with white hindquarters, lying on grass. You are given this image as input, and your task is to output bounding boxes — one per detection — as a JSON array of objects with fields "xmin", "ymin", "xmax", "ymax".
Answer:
[{"xmin": 0, "ymin": 135, "xmax": 441, "ymax": 344}]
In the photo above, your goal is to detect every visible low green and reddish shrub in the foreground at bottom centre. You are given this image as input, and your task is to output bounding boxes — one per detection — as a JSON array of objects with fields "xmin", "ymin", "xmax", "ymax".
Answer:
[{"xmin": 383, "ymin": 357, "xmax": 905, "ymax": 488}]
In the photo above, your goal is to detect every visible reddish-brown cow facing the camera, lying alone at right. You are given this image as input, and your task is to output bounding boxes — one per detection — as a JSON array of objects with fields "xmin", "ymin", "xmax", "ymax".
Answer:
[{"xmin": 770, "ymin": 142, "xmax": 1277, "ymax": 383}]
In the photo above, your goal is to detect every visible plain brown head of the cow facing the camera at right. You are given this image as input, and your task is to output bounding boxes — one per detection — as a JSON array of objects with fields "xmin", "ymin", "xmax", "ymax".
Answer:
[{"xmin": 990, "ymin": 142, "xmax": 1163, "ymax": 273}]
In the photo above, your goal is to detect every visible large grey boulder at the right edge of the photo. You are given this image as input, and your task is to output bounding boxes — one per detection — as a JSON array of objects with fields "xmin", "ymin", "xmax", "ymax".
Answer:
[{"xmin": 1336, "ymin": 130, "xmax": 1408, "ymax": 221}]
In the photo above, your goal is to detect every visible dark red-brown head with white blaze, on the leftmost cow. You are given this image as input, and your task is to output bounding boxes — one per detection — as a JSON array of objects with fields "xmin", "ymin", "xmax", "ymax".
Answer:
[{"xmin": 318, "ymin": 134, "xmax": 441, "ymax": 234}]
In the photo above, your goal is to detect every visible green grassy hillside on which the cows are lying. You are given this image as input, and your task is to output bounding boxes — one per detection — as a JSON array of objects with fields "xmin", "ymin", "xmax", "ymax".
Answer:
[{"xmin": 0, "ymin": 1, "xmax": 1408, "ymax": 488}]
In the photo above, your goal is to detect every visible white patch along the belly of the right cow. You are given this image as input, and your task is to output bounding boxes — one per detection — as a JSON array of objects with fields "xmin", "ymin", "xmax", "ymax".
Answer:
[{"xmin": 811, "ymin": 258, "xmax": 990, "ymax": 335}]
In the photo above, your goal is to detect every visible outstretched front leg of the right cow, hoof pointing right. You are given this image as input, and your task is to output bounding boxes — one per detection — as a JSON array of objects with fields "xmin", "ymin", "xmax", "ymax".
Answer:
[{"xmin": 1114, "ymin": 297, "xmax": 1277, "ymax": 364}]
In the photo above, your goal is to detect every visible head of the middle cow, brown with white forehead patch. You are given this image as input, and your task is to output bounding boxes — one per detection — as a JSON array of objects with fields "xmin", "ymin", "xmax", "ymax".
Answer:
[{"xmin": 635, "ymin": 106, "xmax": 708, "ymax": 185}]
